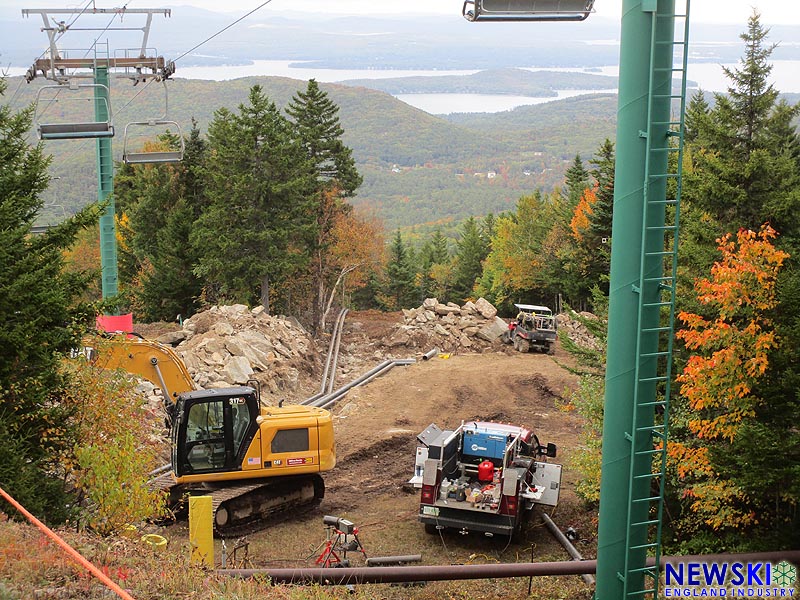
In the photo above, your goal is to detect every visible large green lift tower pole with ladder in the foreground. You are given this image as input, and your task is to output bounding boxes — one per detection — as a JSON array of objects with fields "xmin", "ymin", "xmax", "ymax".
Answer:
[{"xmin": 595, "ymin": 0, "xmax": 688, "ymax": 600}]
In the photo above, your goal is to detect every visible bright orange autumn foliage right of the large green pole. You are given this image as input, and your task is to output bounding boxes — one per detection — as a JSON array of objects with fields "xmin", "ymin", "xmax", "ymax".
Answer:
[{"xmin": 668, "ymin": 225, "xmax": 789, "ymax": 529}]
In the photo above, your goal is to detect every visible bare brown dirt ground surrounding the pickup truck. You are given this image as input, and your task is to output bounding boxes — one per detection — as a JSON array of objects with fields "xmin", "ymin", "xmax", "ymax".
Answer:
[{"xmin": 203, "ymin": 311, "xmax": 596, "ymax": 598}]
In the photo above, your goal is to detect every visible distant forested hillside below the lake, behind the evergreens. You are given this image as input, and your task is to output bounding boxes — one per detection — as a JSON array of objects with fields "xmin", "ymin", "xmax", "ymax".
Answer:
[{"xmin": 9, "ymin": 71, "xmax": 616, "ymax": 229}]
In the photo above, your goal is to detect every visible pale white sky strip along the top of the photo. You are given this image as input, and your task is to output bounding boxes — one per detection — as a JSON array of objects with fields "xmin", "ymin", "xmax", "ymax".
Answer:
[{"xmin": 2, "ymin": 0, "xmax": 800, "ymax": 25}]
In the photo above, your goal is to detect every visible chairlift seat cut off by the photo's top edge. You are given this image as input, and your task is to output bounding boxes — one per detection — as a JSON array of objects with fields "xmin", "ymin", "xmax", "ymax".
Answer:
[{"xmin": 461, "ymin": 0, "xmax": 594, "ymax": 21}]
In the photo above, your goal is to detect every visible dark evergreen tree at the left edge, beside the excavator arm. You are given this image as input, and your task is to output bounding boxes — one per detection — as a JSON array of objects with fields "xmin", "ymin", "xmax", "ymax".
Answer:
[{"xmin": 0, "ymin": 79, "xmax": 102, "ymax": 522}]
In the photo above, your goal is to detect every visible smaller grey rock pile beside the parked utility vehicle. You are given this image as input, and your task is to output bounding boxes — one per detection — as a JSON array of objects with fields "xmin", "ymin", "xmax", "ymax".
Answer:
[{"xmin": 385, "ymin": 298, "xmax": 508, "ymax": 352}]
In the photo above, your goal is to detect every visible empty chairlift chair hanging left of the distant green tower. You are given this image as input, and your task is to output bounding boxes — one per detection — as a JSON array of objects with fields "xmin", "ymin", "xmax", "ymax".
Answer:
[{"xmin": 34, "ymin": 82, "xmax": 114, "ymax": 140}]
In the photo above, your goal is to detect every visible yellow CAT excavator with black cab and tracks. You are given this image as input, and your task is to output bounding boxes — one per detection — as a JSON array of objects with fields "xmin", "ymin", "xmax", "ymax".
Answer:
[{"xmin": 90, "ymin": 334, "xmax": 336, "ymax": 537}]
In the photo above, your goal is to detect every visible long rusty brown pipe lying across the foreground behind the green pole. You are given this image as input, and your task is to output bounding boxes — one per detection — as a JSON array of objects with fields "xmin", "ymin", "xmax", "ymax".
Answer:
[{"xmin": 216, "ymin": 550, "xmax": 800, "ymax": 585}]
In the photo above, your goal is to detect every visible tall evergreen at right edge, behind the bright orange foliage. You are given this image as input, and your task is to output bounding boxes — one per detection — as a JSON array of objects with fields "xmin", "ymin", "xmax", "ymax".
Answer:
[{"xmin": 670, "ymin": 13, "xmax": 800, "ymax": 550}]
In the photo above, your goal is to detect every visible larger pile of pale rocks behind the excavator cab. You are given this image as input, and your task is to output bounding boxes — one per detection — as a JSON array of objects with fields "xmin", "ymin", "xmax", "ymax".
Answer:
[{"xmin": 158, "ymin": 304, "xmax": 321, "ymax": 404}]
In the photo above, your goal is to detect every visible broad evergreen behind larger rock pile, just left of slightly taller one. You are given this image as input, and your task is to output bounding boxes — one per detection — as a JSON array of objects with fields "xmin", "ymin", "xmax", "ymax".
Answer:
[{"xmin": 191, "ymin": 85, "xmax": 315, "ymax": 310}]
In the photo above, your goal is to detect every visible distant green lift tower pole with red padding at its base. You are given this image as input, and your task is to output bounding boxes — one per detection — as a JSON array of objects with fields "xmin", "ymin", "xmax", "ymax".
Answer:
[{"xmin": 94, "ymin": 66, "xmax": 118, "ymax": 300}]
